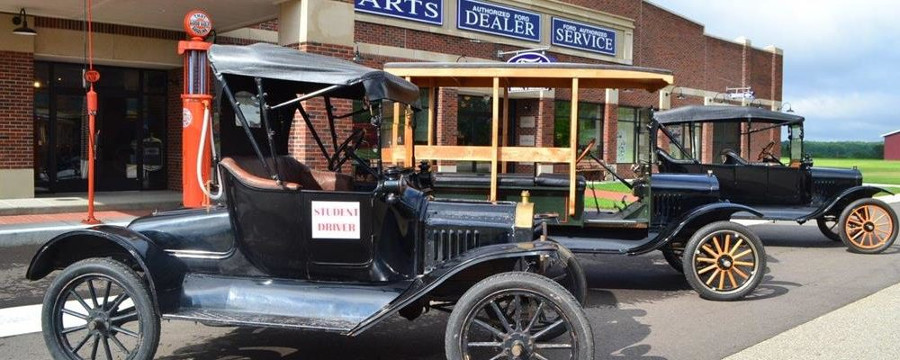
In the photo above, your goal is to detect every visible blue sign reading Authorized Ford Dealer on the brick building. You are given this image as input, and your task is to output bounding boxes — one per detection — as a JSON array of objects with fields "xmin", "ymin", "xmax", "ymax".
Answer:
[{"xmin": 456, "ymin": 0, "xmax": 541, "ymax": 42}]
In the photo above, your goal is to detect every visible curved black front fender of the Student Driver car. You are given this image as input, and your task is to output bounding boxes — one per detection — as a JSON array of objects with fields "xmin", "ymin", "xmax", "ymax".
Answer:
[{"xmin": 346, "ymin": 241, "xmax": 574, "ymax": 336}]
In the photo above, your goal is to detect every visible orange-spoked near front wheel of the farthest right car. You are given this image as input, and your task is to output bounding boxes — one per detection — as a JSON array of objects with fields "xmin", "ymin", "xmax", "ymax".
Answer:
[{"xmin": 839, "ymin": 198, "xmax": 898, "ymax": 254}]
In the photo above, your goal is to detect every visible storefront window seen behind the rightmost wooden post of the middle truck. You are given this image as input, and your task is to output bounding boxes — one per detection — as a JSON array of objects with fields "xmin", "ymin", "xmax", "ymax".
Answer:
[{"xmin": 553, "ymin": 100, "xmax": 603, "ymax": 157}]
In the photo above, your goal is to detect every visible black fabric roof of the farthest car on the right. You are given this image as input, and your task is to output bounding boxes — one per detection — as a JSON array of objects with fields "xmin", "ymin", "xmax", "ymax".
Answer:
[{"xmin": 653, "ymin": 105, "xmax": 803, "ymax": 125}]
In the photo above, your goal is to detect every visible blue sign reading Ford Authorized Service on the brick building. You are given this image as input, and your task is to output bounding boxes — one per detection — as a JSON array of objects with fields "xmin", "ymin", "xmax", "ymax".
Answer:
[{"xmin": 551, "ymin": 17, "xmax": 616, "ymax": 56}]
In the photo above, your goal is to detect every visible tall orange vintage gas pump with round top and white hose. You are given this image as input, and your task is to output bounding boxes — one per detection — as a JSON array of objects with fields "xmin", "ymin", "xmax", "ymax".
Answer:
[{"xmin": 178, "ymin": 10, "xmax": 212, "ymax": 208}]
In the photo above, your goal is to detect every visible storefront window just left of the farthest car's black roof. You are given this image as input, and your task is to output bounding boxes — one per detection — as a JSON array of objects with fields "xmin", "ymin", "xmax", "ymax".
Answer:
[{"xmin": 616, "ymin": 106, "xmax": 650, "ymax": 164}]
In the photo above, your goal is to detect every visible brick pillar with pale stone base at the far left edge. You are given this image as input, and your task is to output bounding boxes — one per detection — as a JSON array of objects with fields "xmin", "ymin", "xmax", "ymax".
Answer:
[{"xmin": 0, "ymin": 49, "xmax": 35, "ymax": 199}]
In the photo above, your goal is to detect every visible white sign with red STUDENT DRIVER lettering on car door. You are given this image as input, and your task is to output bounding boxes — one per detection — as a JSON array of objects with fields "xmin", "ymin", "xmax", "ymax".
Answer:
[{"xmin": 311, "ymin": 201, "xmax": 360, "ymax": 239}]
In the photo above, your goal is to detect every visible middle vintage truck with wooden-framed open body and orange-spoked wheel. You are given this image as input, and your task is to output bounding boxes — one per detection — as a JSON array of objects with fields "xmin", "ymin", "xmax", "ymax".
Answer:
[{"xmin": 383, "ymin": 63, "xmax": 766, "ymax": 300}]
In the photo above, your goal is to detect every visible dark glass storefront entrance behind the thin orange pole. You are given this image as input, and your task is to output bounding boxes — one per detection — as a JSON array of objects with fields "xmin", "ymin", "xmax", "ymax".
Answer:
[{"xmin": 34, "ymin": 62, "xmax": 168, "ymax": 192}]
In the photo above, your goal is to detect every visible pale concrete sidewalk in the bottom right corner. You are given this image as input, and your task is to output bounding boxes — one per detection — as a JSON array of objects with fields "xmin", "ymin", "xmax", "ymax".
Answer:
[{"xmin": 726, "ymin": 284, "xmax": 900, "ymax": 360}]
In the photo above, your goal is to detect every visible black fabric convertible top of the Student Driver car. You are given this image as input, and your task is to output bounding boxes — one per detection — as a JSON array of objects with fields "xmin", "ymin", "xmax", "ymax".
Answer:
[{"xmin": 209, "ymin": 43, "xmax": 419, "ymax": 104}]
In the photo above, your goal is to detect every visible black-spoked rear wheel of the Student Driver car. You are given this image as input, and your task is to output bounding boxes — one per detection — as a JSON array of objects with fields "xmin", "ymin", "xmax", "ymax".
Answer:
[{"xmin": 41, "ymin": 258, "xmax": 160, "ymax": 360}]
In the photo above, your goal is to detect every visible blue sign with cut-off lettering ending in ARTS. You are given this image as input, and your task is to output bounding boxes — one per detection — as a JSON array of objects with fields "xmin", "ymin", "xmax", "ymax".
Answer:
[{"xmin": 355, "ymin": 0, "xmax": 444, "ymax": 25}]
